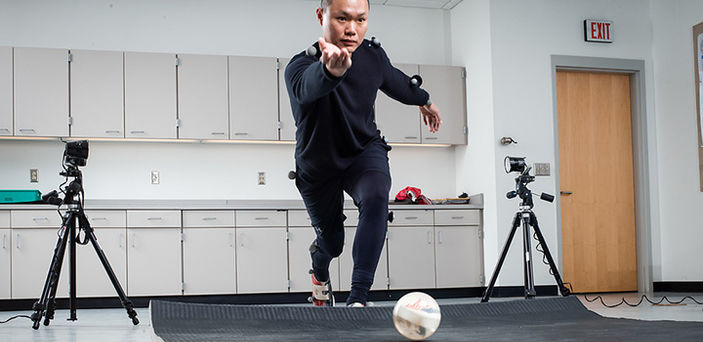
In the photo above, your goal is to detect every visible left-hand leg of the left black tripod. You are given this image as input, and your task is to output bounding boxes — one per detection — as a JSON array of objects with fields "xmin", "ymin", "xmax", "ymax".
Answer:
[{"xmin": 32, "ymin": 212, "xmax": 73, "ymax": 330}]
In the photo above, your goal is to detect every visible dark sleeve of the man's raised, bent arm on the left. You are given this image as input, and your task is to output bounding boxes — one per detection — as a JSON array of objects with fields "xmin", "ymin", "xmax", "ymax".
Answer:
[{"xmin": 285, "ymin": 55, "xmax": 344, "ymax": 105}]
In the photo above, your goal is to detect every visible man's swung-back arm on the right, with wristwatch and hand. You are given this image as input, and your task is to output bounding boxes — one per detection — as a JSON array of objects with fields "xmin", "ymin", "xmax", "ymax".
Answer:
[{"xmin": 380, "ymin": 49, "xmax": 442, "ymax": 133}]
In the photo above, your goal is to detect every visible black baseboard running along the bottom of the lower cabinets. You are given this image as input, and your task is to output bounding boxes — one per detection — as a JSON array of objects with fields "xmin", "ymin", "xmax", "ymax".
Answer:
[{"xmin": 0, "ymin": 285, "xmax": 558, "ymax": 311}]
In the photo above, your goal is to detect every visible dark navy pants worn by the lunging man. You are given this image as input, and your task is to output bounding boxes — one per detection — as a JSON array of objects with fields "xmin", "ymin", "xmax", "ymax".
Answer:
[{"xmin": 296, "ymin": 141, "xmax": 391, "ymax": 304}]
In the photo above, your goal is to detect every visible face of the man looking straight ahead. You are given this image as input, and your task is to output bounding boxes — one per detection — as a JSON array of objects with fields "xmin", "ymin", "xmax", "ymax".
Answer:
[{"xmin": 317, "ymin": 0, "xmax": 369, "ymax": 52}]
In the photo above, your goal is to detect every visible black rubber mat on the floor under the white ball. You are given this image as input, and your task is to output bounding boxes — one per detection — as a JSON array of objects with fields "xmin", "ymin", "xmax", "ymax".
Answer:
[{"xmin": 151, "ymin": 297, "xmax": 703, "ymax": 342}]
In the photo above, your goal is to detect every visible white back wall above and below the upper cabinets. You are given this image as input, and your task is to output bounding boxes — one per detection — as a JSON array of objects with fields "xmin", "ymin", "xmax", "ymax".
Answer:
[{"xmin": 0, "ymin": 0, "xmax": 456, "ymax": 199}]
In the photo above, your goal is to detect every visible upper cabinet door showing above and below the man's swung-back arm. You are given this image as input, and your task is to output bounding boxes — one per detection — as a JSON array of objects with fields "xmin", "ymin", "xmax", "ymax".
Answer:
[{"xmin": 376, "ymin": 64, "xmax": 421, "ymax": 143}]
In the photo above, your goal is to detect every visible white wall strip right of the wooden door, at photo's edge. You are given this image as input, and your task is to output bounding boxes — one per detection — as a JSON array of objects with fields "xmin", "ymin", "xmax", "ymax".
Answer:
[{"xmin": 651, "ymin": 0, "xmax": 703, "ymax": 281}]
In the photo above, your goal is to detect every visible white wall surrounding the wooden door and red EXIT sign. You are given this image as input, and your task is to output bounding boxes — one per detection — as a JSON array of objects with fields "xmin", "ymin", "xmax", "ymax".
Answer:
[{"xmin": 452, "ymin": 0, "xmax": 660, "ymax": 286}]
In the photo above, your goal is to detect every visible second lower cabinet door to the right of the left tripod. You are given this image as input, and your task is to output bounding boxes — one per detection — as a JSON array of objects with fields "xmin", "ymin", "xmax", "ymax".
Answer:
[{"xmin": 183, "ymin": 227, "xmax": 237, "ymax": 295}]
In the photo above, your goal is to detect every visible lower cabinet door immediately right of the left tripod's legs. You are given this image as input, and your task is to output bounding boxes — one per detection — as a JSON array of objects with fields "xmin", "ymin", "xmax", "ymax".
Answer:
[{"xmin": 127, "ymin": 228, "xmax": 182, "ymax": 296}]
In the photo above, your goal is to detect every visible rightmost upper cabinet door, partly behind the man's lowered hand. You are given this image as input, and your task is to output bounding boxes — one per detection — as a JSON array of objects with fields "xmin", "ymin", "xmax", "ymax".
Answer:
[{"xmin": 420, "ymin": 65, "xmax": 466, "ymax": 145}]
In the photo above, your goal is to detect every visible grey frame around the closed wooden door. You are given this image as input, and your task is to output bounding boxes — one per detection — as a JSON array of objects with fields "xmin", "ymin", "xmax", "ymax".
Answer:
[{"xmin": 550, "ymin": 55, "xmax": 653, "ymax": 293}]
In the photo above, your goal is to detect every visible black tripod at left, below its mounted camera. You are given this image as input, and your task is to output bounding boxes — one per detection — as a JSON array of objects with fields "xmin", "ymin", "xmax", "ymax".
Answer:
[{"xmin": 32, "ymin": 163, "xmax": 139, "ymax": 329}]
